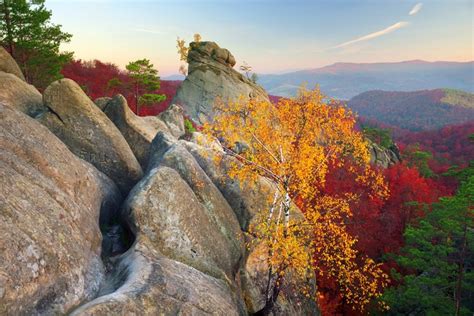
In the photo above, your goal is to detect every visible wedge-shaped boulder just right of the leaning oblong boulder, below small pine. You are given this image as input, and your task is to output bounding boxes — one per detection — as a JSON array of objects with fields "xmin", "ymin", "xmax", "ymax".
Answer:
[{"xmin": 103, "ymin": 94, "xmax": 163, "ymax": 168}]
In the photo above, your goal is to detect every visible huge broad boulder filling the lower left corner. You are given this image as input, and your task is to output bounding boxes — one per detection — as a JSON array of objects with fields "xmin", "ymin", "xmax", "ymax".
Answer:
[{"xmin": 0, "ymin": 104, "xmax": 121, "ymax": 315}]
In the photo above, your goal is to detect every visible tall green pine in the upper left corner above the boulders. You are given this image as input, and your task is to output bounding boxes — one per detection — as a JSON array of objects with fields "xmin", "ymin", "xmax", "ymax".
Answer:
[{"xmin": 0, "ymin": 0, "xmax": 72, "ymax": 89}]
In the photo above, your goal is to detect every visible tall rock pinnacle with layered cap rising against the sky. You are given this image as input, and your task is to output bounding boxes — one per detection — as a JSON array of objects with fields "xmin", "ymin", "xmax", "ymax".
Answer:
[{"xmin": 172, "ymin": 42, "xmax": 268, "ymax": 123}]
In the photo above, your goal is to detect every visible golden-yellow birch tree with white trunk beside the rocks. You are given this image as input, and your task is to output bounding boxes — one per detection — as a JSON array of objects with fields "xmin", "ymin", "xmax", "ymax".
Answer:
[{"xmin": 203, "ymin": 88, "xmax": 388, "ymax": 315}]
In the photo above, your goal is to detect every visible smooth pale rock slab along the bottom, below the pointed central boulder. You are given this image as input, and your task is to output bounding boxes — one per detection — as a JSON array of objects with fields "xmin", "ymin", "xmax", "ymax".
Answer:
[{"xmin": 72, "ymin": 242, "xmax": 246, "ymax": 316}]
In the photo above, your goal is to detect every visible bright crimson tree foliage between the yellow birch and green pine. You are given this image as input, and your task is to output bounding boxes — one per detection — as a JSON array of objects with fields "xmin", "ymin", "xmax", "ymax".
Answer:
[{"xmin": 318, "ymin": 163, "xmax": 450, "ymax": 315}]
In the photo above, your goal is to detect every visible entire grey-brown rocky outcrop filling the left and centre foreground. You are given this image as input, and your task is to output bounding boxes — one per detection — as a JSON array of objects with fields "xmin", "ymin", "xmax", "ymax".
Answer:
[{"xmin": 0, "ymin": 43, "xmax": 318, "ymax": 315}]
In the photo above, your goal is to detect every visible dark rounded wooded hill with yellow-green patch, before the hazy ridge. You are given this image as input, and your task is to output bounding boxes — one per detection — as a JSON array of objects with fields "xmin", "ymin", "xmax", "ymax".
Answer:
[{"xmin": 347, "ymin": 89, "xmax": 474, "ymax": 131}]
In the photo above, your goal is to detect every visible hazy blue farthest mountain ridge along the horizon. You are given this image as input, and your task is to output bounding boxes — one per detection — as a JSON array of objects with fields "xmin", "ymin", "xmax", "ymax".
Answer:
[{"xmin": 258, "ymin": 60, "xmax": 474, "ymax": 100}]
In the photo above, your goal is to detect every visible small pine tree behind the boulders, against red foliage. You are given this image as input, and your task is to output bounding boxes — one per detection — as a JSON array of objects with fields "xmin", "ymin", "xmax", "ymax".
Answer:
[{"xmin": 126, "ymin": 59, "xmax": 166, "ymax": 114}]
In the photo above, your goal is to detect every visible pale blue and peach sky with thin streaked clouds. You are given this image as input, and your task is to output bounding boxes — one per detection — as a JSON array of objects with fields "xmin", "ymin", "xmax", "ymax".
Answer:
[{"xmin": 46, "ymin": 0, "xmax": 474, "ymax": 77}]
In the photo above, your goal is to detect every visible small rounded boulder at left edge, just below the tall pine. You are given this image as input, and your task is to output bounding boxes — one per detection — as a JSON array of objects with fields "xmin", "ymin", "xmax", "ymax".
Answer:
[{"xmin": 0, "ymin": 71, "xmax": 46, "ymax": 117}]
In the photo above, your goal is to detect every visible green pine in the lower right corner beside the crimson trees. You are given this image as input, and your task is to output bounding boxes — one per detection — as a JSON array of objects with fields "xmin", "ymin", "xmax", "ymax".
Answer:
[{"xmin": 383, "ymin": 164, "xmax": 474, "ymax": 315}]
